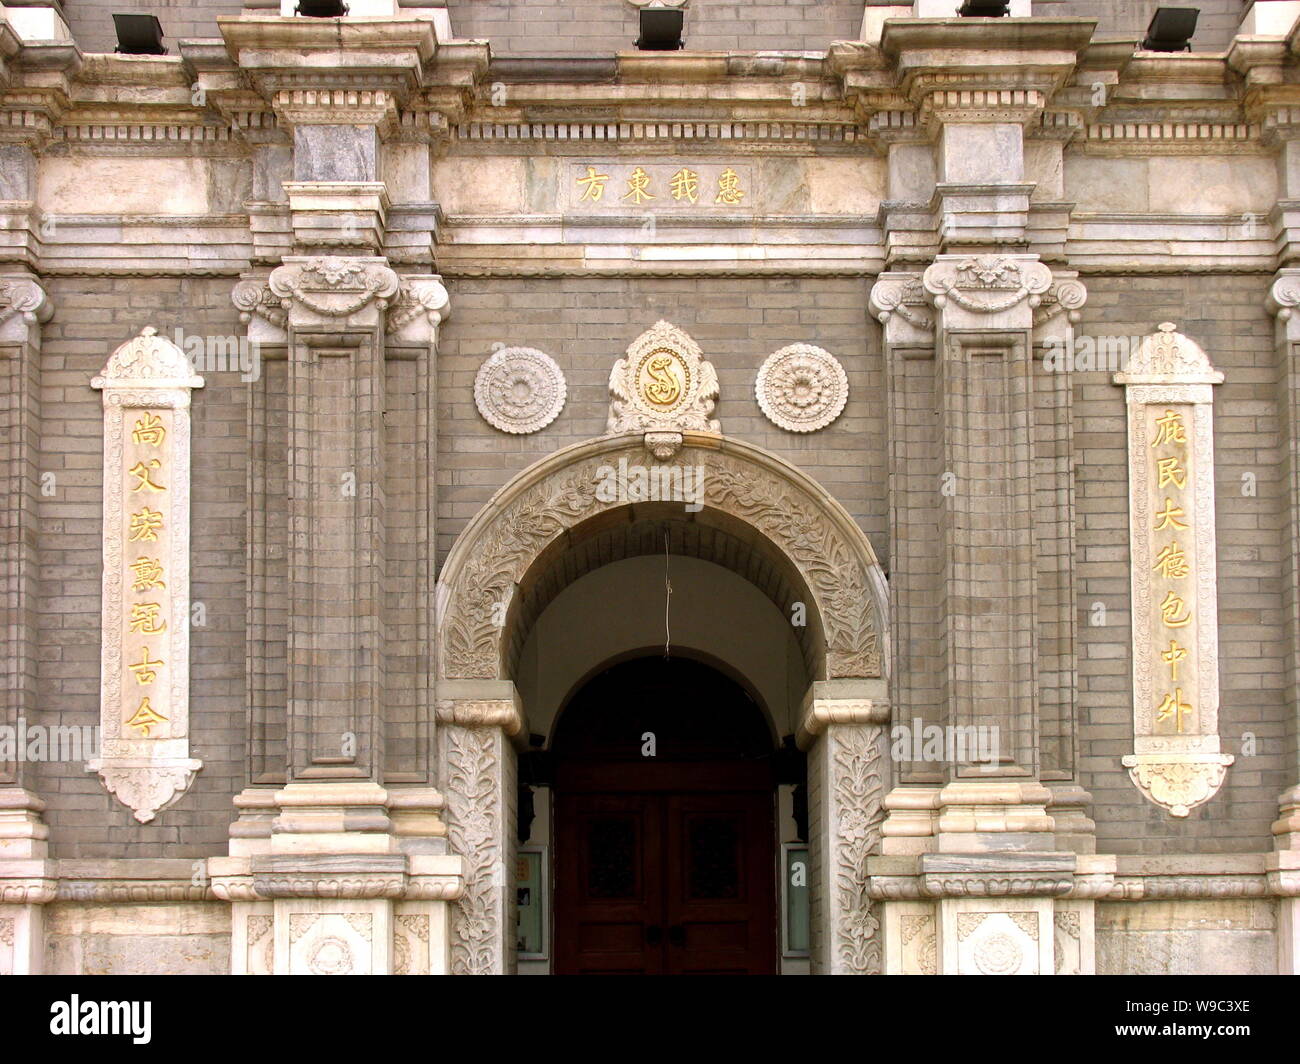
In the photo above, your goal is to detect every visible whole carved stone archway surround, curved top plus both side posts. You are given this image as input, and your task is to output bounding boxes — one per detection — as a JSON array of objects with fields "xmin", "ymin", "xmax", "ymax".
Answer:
[{"xmin": 436, "ymin": 432, "xmax": 889, "ymax": 974}]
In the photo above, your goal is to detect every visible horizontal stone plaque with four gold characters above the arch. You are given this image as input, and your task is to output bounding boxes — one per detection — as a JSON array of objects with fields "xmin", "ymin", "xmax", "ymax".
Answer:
[{"xmin": 563, "ymin": 161, "xmax": 754, "ymax": 213}]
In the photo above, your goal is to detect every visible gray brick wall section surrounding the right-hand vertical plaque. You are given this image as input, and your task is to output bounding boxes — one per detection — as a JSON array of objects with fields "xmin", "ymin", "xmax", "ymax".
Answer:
[{"xmin": 1075, "ymin": 276, "xmax": 1294, "ymax": 855}]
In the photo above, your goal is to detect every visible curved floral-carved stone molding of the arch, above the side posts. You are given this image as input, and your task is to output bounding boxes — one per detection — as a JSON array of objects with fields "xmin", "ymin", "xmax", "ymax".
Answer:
[{"xmin": 438, "ymin": 432, "xmax": 889, "ymax": 679}]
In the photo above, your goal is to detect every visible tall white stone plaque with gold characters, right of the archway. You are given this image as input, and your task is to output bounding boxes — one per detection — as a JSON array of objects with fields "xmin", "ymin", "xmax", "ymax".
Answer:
[{"xmin": 1114, "ymin": 323, "xmax": 1232, "ymax": 817}]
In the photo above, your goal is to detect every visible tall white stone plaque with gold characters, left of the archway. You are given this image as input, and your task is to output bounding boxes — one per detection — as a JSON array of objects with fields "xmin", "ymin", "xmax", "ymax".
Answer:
[{"xmin": 87, "ymin": 328, "xmax": 203, "ymax": 822}]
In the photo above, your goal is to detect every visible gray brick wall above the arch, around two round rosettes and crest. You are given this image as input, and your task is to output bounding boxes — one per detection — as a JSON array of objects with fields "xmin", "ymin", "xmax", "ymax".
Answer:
[{"xmin": 438, "ymin": 277, "xmax": 888, "ymax": 565}]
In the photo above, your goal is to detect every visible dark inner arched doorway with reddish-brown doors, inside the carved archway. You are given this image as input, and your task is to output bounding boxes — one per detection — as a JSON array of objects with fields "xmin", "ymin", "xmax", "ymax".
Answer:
[{"xmin": 551, "ymin": 654, "xmax": 777, "ymax": 974}]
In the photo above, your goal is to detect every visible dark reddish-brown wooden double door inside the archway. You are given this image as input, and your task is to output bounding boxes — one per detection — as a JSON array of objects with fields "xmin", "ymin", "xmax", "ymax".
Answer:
[{"xmin": 555, "ymin": 785, "xmax": 776, "ymax": 976}]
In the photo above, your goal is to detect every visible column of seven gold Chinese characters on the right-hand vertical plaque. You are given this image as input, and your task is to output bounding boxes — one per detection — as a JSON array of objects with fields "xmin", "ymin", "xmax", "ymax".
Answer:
[{"xmin": 1149, "ymin": 408, "xmax": 1196, "ymax": 735}]
